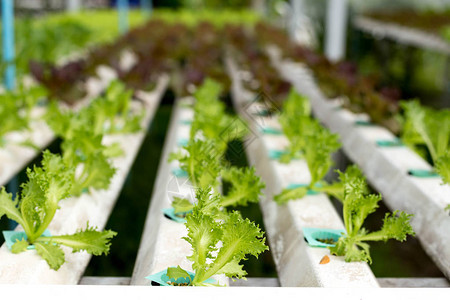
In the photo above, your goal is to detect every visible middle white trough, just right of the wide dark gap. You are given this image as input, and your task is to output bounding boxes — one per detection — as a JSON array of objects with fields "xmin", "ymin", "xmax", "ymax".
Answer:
[{"xmin": 131, "ymin": 98, "xmax": 228, "ymax": 285}]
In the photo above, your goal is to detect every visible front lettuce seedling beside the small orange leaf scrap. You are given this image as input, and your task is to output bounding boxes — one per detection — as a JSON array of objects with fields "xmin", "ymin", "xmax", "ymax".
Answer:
[{"xmin": 329, "ymin": 172, "xmax": 415, "ymax": 263}]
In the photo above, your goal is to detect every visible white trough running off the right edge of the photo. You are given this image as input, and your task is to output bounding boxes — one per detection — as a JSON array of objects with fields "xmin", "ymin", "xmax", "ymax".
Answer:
[{"xmin": 269, "ymin": 48, "xmax": 450, "ymax": 278}]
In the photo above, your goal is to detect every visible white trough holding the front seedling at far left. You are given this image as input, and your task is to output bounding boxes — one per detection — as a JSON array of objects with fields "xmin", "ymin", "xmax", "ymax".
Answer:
[{"xmin": 0, "ymin": 76, "xmax": 168, "ymax": 284}]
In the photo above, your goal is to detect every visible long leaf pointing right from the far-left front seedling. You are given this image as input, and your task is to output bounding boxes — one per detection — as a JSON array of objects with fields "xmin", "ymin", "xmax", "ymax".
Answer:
[{"xmin": 37, "ymin": 223, "xmax": 117, "ymax": 255}]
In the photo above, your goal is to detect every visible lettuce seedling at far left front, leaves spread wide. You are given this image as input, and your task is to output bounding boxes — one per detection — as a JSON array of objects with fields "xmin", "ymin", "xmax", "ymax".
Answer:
[{"xmin": 0, "ymin": 151, "xmax": 116, "ymax": 270}]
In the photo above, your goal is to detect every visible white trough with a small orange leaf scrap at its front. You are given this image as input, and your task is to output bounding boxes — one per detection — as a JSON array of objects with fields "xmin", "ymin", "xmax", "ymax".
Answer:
[{"xmin": 227, "ymin": 59, "xmax": 378, "ymax": 288}]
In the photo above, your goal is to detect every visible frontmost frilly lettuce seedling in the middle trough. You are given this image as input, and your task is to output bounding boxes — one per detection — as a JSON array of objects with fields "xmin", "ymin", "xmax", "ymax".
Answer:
[{"xmin": 168, "ymin": 189, "xmax": 268, "ymax": 286}]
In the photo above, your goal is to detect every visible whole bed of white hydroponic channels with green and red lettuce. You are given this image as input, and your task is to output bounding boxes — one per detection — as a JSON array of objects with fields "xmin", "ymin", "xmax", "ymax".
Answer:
[{"xmin": 0, "ymin": 20, "xmax": 450, "ymax": 287}]
